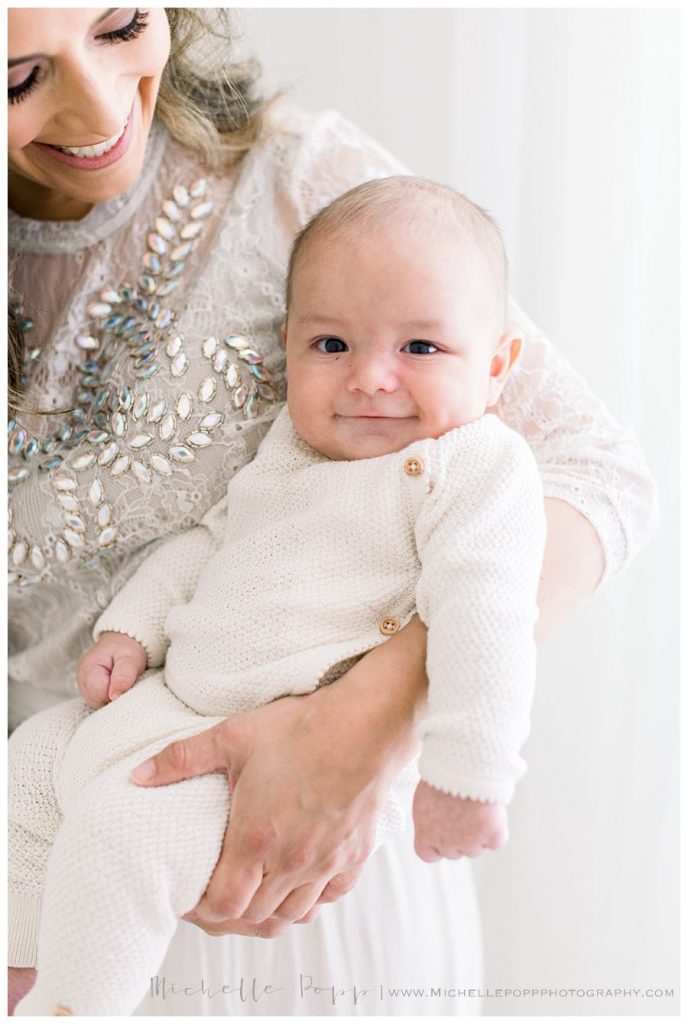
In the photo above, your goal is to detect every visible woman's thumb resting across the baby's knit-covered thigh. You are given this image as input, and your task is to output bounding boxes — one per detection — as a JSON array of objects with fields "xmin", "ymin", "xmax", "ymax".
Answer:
[{"xmin": 129, "ymin": 722, "xmax": 230, "ymax": 785}]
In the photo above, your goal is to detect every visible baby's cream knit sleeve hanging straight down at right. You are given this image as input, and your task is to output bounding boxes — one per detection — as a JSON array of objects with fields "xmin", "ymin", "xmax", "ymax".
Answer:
[{"xmin": 416, "ymin": 417, "xmax": 546, "ymax": 803}]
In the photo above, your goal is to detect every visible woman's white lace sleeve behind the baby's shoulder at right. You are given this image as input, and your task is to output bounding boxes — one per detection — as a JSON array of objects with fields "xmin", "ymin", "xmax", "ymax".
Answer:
[{"xmin": 497, "ymin": 301, "xmax": 657, "ymax": 581}]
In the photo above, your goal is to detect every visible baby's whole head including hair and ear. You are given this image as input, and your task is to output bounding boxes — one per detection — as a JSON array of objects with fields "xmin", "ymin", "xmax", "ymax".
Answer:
[{"xmin": 284, "ymin": 177, "xmax": 521, "ymax": 460}]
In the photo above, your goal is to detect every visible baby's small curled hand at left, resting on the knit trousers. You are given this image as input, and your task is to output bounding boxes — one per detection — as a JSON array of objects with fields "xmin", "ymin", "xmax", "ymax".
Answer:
[{"xmin": 77, "ymin": 633, "xmax": 147, "ymax": 708}]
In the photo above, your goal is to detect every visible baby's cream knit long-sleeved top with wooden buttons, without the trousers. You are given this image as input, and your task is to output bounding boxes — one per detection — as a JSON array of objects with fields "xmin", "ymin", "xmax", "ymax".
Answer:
[{"xmin": 95, "ymin": 409, "xmax": 545, "ymax": 802}]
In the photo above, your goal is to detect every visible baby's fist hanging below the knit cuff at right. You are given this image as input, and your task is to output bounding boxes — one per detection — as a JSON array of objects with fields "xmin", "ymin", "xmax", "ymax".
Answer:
[{"xmin": 414, "ymin": 781, "xmax": 509, "ymax": 862}]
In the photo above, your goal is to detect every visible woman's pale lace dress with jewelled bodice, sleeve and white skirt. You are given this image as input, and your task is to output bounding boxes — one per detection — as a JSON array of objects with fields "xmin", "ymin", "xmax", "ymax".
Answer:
[{"xmin": 9, "ymin": 103, "xmax": 654, "ymax": 1016}]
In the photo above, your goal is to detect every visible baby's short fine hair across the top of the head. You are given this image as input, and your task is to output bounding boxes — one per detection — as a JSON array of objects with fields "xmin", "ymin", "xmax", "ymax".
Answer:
[{"xmin": 287, "ymin": 175, "xmax": 507, "ymax": 331}]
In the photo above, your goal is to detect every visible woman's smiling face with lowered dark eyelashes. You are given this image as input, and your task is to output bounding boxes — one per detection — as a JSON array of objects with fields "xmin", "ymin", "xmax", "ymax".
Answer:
[{"xmin": 7, "ymin": 8, "xmax": 170, "ymax": 220}]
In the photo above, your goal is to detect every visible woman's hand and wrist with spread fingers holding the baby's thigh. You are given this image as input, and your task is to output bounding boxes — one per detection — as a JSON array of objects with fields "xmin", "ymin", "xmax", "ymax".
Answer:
[{"xmin": 132, "ymin": 618, "xmax": 427, "ymax": 936}]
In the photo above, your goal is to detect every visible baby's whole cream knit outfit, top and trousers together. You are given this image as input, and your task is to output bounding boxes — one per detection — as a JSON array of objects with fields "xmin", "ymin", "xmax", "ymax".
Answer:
[{"xmin": 10, "ymin": 409, "xmax": 545, "ymax": 1016}]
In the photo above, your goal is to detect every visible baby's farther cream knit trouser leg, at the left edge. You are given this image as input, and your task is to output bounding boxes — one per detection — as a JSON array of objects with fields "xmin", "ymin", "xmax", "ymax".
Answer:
[{"xmin": 7, "ymin": 700, "xmax": 90, "ymax": 968}]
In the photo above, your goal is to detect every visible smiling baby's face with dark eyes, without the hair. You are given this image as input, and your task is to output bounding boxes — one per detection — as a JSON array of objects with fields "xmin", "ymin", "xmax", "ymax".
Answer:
[{"xmin": 285, "ymin": 225, "xmax": 509, "ymax": 460}]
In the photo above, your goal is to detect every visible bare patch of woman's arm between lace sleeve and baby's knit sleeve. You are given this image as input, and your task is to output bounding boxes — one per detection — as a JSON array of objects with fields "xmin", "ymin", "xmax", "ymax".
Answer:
[{"xmin": 534, "ymin": 498, "xmax": 604, "ymax": 646}]
